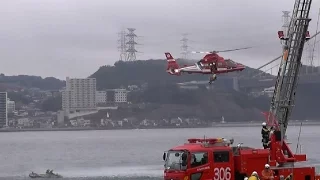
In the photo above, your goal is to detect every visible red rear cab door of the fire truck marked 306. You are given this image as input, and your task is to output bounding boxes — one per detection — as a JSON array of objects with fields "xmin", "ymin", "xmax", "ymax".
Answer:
[{"xmin": 212, "ymin": 150, "xmax": 234, "ymax": 180}]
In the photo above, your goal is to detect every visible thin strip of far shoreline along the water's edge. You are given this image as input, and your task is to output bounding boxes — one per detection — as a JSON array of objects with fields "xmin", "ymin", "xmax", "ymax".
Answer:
[{"xmin": 0, "ymin": 121, "xmax": 320, "ymax": 132}]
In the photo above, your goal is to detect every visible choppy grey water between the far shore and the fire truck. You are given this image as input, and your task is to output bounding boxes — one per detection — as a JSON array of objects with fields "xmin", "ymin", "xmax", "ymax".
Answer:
[{"xmin": 0, "ymin": 126, "xmax": 320, "ymax": 180}]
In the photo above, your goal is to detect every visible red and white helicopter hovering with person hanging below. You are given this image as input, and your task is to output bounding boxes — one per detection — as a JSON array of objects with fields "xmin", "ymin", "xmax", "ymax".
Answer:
[{"xmin": 165, "ymin": 47, "xmax": 251, "ymax": 84}]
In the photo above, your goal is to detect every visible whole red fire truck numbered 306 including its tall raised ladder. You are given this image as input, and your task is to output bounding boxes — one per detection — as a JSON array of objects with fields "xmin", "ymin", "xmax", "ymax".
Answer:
[{"xmin": 163, "ymin": 0, "xmax": 320, "ymax": 180}]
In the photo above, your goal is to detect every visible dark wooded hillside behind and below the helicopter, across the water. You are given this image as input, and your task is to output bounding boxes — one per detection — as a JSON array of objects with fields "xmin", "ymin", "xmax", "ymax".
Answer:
[{"xmin": 87, "ymin": 60, "xmax": 320, "ymax": 121}]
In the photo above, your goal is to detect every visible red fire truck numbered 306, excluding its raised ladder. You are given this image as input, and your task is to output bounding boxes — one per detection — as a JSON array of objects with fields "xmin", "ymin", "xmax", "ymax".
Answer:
[{"xmin": 163, "ymin": 136, "xmax": 320, "ymax": 180}]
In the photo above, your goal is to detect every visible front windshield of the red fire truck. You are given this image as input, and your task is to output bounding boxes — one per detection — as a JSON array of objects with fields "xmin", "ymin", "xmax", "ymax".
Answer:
[{"xmin": 164, "ymin": 151, "xmax": 187, "ymax": 170}]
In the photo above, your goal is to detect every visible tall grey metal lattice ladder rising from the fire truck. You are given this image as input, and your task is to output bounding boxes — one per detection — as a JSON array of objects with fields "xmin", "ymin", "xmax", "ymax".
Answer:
[{"xmin": 268, "ymin": 0, "xmax": 312, "ymax": 141}]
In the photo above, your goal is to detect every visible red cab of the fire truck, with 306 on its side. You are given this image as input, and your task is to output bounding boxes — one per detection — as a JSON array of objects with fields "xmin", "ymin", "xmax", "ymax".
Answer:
[{"xmin": 163, "ymin": 139, "xmax": 234, "ymax": 180}]
